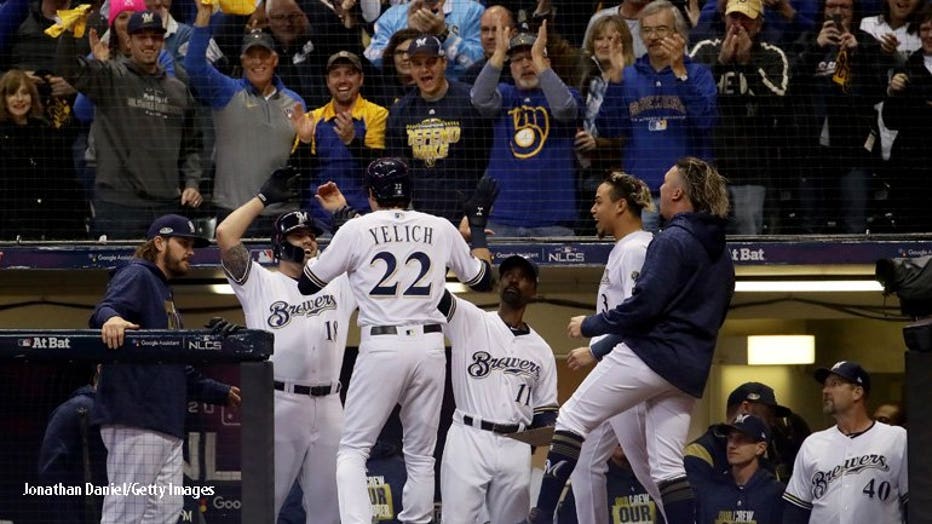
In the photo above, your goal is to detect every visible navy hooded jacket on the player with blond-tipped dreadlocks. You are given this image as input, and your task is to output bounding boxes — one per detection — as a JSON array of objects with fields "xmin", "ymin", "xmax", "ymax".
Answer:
[{"xmin": 582, "ymin": 213, "xmax": 735, "ymax": 398}]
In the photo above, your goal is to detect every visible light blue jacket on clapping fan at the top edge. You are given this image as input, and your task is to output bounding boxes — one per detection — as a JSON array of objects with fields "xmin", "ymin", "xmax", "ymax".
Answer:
[{"xmin": 365, "ymin": 0, "xmax": 485, "ymax": 80}]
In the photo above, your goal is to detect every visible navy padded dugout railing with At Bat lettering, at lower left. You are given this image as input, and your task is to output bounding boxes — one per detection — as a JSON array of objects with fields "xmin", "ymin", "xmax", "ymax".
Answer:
[{"xmin": 0, "ymin": 329, "xmax": 274, "ymax": 524}]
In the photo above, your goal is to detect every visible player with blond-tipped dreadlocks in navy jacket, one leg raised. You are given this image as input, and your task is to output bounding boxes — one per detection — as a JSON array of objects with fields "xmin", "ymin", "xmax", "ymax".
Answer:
[{"xmin": 528, "ymin": 157, "xmax": 735, "ymax": 523}]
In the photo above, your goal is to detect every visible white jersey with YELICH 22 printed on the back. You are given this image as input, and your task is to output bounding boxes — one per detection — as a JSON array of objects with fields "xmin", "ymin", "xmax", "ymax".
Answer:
[{"xmin": 304, "ymin": 209, "xmax": 485, "ymax": 326}]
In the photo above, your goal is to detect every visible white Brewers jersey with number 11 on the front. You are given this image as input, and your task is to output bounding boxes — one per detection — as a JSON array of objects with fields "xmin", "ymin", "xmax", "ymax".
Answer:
[{"xmin": 446, "ymin": 297, "xmax": 557, "ymax": 425}]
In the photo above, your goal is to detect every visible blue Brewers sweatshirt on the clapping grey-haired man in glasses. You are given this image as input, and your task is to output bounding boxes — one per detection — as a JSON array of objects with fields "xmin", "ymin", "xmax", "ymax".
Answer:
[{"xmin": 596, "ymin": 55, "xmax": 718, "ymax": 193}]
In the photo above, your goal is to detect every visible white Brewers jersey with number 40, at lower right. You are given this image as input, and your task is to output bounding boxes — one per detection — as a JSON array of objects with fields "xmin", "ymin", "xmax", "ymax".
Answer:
[{"xmin": 783, "ymin": 422, "xmax": 909, "ymax": 524}]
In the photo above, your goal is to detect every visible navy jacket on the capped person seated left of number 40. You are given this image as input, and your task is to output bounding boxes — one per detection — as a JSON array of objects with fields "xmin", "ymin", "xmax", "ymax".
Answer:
[{"xmin": 696, "ymin": 468, "xmax": 786, "ymax": 524}]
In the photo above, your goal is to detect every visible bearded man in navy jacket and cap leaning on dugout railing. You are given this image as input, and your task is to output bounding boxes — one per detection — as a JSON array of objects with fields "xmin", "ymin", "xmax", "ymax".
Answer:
[{"xmin": 89, "ymin": 215, "xmax": 241, "ymax": 524}]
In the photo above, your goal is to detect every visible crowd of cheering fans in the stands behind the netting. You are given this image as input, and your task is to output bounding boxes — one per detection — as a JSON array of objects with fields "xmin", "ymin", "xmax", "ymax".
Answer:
[{"xmin": 0, "ymin": 0, "xmax": 932, "ymax": 240}]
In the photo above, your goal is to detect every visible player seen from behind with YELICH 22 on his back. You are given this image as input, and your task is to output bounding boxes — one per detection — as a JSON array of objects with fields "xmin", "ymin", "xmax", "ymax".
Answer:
[{"xmin": 298, "ymin": 158, "xmax": 494, "ymax": 524}]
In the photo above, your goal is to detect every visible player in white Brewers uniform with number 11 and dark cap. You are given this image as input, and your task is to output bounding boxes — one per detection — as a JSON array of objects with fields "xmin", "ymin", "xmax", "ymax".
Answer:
[{"xmin": 438, "ymin": 255, "xmax": 557, "ymax": 524}]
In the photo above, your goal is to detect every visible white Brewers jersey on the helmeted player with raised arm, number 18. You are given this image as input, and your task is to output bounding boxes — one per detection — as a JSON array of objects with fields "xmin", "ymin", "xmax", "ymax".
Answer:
[{"xmin": 227, "ymin": 261, "xmax": 356, "ymax": 385}]
